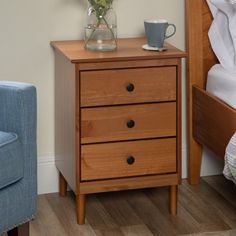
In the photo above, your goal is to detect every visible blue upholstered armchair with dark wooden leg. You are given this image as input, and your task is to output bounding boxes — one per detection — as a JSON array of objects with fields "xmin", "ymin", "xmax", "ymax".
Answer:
[{"xmin": 0, "ymin": 81, "xmax": 37, "ymax": 236}]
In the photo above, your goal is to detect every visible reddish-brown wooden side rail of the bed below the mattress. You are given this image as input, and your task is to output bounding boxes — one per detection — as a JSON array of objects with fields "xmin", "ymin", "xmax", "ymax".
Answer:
[{"xmin": 193, "ymin": 86, "xmax": 236, "ymax": 159}]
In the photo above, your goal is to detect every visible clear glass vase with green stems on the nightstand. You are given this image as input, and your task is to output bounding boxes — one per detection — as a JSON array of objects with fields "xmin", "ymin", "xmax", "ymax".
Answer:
[{"xmin": 85, "ymin": 5, "xmax": 117, "ymax": 51}]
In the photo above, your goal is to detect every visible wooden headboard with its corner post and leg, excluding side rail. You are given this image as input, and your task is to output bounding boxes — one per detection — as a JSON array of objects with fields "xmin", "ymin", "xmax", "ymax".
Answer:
[{"xmin": 186, "ymin": 0, "xmax": 217, "ymax": 184}]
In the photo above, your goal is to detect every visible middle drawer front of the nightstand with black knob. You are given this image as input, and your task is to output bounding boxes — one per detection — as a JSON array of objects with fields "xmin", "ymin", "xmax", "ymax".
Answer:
[{"xmin": 81, "ymin": 102, "xmax": 176, "ymax": 144}]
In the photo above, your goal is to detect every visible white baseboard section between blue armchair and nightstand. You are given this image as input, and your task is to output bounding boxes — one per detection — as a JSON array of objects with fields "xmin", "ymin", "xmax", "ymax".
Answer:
[{"xmin": 38, "ymin": 156, "xmax": 59, "ymax": 194}]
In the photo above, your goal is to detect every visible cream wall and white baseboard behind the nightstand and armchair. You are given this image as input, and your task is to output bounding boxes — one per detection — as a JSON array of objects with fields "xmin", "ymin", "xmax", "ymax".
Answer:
[{"xmin": 0, "ymin": 0, "xmax": 222, "ymax": 193}]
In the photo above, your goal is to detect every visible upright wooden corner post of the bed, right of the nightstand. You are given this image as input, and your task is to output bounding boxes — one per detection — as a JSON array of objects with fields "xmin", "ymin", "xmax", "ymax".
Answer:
[{"xmin": 185, "ymin": 0, "xmax": 205, "ymax": 184}]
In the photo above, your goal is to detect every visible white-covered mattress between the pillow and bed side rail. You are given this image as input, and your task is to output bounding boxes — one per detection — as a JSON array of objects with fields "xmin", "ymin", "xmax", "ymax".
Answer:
[{"xmin": 206, "ymin": 64, "xmax": 236, "ymax": 109}]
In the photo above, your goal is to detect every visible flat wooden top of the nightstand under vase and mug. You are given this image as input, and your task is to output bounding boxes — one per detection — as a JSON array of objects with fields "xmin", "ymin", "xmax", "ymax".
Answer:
[{"xmin": 51, "ymin": 38, "xmax": 186, "ymax": 63}]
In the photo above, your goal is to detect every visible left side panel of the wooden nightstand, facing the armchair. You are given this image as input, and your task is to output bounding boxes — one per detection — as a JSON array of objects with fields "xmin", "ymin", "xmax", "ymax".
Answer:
[{"xmin": 55, "ymin": 49, "xmax": 77, "ymax": 191}]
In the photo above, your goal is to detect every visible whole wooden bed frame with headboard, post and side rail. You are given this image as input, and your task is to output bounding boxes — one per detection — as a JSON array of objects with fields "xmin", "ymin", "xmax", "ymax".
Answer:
[{"xmin": 186, "ymin": 0, "xmax": 236, "ymax": 184}]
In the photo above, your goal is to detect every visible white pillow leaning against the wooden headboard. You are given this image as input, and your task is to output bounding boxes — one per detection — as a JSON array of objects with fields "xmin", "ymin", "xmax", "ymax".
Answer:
[{"xmin": 208, "ymin": 0, "xmax": 236, "ymax": 69}]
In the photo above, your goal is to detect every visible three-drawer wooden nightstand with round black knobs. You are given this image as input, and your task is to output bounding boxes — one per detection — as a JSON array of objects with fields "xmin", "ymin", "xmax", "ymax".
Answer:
[{"xmin": 52, "ymin": 38, "xmax": 186, "ymax": 224}]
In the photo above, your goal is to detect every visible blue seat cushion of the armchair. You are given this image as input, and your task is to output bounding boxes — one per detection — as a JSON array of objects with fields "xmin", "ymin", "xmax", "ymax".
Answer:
[{"xmin": 0, "ymin": 131, "xmax": 24, "ymax": 189}]
